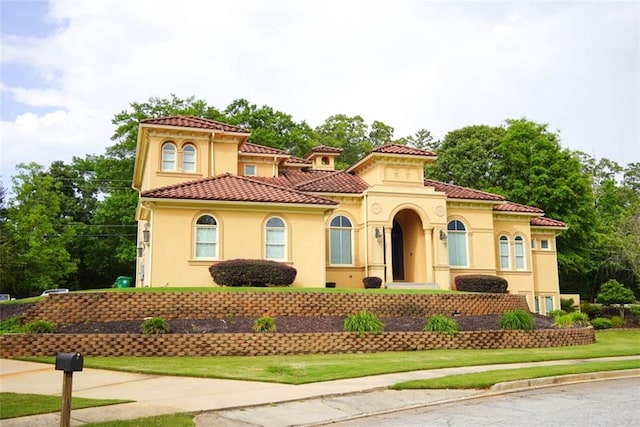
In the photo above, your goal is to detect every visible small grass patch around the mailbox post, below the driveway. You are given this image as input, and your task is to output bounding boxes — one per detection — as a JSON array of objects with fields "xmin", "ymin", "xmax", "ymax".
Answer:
[{"xmin": 0, "ymin": 392, "xmax": 131, "ymax": 420}]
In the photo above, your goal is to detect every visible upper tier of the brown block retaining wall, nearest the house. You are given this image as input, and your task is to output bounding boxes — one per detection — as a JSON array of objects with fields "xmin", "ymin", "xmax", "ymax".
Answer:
[{"xmin": 23, "ymin": 290, "xmax": 529, "ymax": 325}]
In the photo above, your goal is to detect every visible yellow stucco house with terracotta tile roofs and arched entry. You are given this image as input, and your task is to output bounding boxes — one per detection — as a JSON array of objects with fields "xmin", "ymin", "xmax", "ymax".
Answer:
[{"xmin": 133, "ymin": 116, "xmax": 566, "ymax": 313}]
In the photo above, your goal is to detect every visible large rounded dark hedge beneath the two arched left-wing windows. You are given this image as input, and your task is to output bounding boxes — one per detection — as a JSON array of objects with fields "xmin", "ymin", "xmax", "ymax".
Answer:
[{"xmin": 209, "ymin": 259, "xmax": 298, "ymax": 286}]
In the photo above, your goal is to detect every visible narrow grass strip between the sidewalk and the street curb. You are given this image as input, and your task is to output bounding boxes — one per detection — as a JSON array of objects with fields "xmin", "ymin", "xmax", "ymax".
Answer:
[{"xmin": 390, "ymin": 359, "xmax": 640, "ymax": 390}]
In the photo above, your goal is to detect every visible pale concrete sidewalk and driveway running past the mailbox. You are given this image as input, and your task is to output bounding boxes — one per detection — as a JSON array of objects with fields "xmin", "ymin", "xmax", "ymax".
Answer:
[{"xmin": 0, "ymin": 356, "xmax": 640, "ymax": 427}]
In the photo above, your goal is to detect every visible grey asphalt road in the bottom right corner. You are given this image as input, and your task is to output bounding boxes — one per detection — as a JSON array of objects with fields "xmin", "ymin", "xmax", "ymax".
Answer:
[{"xmin": 331, "ymin": 378, "xmax": 640, "ymax": 427}]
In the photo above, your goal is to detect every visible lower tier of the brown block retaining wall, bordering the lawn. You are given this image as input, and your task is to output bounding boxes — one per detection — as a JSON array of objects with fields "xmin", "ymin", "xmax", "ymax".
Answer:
[{"xmin": 0, "ymin": 328, "xmax": 595, "ymax": 357}]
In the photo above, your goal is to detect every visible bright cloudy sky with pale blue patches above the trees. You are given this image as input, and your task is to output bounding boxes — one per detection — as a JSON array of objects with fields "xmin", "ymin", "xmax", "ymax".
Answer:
[{"xmin": 0, "ymin": 0, "xmax": 640, "ymax": 189}]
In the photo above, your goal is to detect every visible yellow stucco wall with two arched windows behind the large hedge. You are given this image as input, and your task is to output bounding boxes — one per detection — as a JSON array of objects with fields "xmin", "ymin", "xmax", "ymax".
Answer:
[{"xmin": 139, "ymin": 203, "xmax": 325, "ymax": 287}]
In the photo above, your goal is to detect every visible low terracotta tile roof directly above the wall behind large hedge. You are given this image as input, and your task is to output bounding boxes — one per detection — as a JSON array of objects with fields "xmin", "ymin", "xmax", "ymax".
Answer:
[{"xmin": 142, "ymin": 174, "xmax": 337, "ymax": 206}]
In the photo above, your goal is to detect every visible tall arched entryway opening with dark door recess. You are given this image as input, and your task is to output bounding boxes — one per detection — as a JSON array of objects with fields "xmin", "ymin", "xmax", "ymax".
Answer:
[{"xmin": 391, "ymin": 209, "xmax": 426, "ymax": 282}]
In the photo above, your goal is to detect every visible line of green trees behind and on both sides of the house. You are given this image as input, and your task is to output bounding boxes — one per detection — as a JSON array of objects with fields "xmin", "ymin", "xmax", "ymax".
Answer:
[{"xmin": 0, "ymin": 95, "xmax": 640, "ymax": 300}]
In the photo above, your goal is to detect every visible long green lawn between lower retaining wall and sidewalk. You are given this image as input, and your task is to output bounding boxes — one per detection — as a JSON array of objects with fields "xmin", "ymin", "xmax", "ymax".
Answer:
[{"xmin": 22, "ymin": 330, "xmax": 640, "ymax": 384}]
